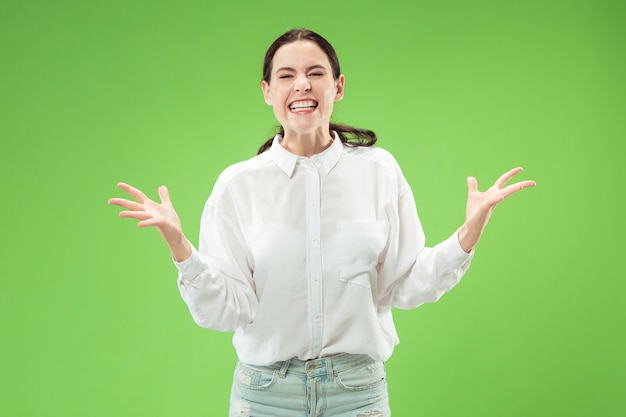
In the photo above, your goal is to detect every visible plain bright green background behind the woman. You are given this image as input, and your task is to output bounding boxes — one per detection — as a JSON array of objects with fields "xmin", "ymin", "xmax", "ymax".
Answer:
[{"xmin": 0, "ymin": 0, "xmax": 626, "ymax": 417}]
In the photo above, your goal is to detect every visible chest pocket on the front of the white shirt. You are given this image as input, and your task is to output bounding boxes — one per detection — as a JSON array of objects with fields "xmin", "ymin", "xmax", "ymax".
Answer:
[{"xmin": 337, "ymin": 221, "xmax": 389, "ymax": 288}]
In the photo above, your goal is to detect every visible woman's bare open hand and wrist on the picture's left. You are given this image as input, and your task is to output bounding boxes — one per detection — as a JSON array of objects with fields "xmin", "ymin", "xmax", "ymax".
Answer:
[{"xmin": 109, "ymin": 182, "xmax": 191, "ymax": 262}]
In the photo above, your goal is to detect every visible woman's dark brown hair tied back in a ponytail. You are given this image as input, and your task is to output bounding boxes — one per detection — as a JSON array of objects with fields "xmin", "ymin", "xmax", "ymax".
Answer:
[{"xmin": 258, "ymin": 29, "xmax": 377, "ymax": 154}]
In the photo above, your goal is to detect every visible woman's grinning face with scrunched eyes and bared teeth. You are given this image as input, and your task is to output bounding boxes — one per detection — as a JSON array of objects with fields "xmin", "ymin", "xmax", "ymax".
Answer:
[{"xmin": 261, "ymin": 41, "xmax": 345, "ymax": 137}]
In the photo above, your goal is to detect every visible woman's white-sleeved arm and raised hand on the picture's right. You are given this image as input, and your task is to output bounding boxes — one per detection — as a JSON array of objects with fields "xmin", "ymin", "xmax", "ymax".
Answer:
[{"xmin": 381, "ymin": 168, "xmax": 535, "ymax": 309}]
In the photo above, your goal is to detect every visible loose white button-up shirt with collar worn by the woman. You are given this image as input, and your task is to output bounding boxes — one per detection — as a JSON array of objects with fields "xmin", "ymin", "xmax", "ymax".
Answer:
[{"xmin": 175, "ymin": 136, "xmax": 473, "ymax": 365}]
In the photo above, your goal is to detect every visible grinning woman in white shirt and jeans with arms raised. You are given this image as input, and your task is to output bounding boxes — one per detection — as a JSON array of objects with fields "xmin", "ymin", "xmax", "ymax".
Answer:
[{"xmin": 109, "ymin": 29, "xmax": 535, "ymax": 417}]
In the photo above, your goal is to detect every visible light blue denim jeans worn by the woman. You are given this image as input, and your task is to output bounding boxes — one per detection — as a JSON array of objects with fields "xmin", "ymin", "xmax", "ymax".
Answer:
[{"xmin": 229, "ymin": 354, "xmax": 391, "ymax": 417}]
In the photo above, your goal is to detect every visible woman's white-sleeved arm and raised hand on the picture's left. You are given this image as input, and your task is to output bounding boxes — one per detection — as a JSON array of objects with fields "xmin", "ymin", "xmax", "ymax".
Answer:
[{"xmin": 109, "ymin": 183, "xmax": 258, "ymax": 331}]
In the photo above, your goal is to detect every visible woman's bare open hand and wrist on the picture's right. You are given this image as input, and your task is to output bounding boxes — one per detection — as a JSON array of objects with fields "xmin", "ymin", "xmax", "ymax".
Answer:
[{"xmin": 458, "ymin": 167, "xmax": 536, "ymax": 253}]
